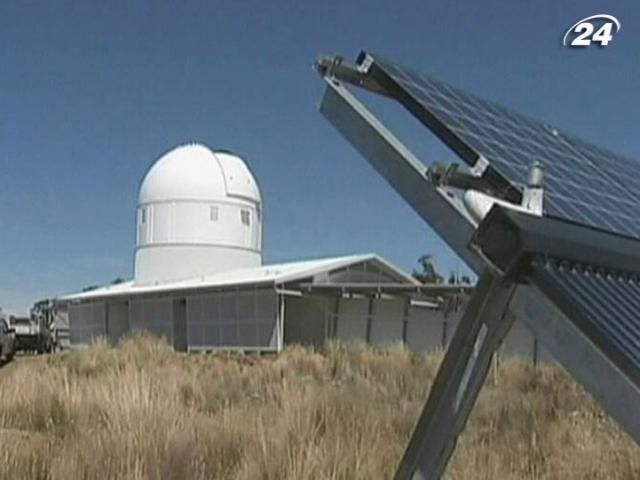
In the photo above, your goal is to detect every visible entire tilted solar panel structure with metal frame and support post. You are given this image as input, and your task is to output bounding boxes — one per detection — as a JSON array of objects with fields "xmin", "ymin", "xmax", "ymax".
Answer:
[{"xmin": 319, "ymin": 54, "xmax": 640, "ymax": 480}]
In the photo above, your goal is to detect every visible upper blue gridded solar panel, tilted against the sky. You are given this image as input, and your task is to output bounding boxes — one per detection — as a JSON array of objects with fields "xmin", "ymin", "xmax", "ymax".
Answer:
[{"xmin": 361, "ymin": 54, "xmax": 640, "ymax": 238}]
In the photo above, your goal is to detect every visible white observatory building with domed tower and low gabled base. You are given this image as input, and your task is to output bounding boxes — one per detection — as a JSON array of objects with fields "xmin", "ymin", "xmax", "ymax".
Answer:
[{"xmin": 59, "ymin": 143, "xmax": 470, "ymax": 351}]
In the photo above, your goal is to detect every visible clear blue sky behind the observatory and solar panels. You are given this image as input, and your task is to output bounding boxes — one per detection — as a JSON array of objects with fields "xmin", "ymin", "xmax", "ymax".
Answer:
[{"xmin": 0, "ymin": 0, "xmax": 640, "ymax": 311}]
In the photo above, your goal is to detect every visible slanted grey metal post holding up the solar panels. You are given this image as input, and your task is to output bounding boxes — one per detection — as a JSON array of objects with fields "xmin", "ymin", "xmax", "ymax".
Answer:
[{"xmin": 395, "ymin": 272, "xmax": 515, "ymax": 480}]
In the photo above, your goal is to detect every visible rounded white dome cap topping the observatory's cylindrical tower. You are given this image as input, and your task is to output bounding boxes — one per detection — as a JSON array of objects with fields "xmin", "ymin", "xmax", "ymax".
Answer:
[{"xmin": 138, "ymin": 143, "xmax": 260, "ymax": 204}]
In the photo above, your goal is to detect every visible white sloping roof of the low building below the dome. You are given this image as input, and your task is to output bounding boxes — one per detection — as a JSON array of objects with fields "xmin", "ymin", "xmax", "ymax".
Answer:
[{"xmin": 60, "ymin": 253, "xmax": 418, "ymax": 301}]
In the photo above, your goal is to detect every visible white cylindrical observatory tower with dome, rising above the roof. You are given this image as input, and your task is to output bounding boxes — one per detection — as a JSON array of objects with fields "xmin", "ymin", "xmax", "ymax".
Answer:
[{"xmin": 135, "ymin": 144, "xmax": 262, "ymax": 284}]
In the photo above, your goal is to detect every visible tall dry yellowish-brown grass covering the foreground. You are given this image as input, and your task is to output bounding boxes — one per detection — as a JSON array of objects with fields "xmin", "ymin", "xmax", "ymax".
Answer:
[{"xmin": 0, "ymin": 336, "xmax": 640, "ymax": 480}]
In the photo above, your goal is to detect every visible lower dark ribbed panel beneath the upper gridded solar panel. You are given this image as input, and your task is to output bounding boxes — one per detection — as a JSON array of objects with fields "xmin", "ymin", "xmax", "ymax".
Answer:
[{"xmin": 532, "ymin": 259, "xmax": 640, "ymax": 383}]
